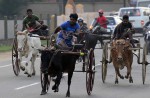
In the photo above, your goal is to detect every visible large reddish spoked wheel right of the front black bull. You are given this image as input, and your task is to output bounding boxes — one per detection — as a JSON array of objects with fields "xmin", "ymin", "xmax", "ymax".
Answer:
[{"xmin": 86, "ymin": 48, "xmax": 95, "ymax": 95}]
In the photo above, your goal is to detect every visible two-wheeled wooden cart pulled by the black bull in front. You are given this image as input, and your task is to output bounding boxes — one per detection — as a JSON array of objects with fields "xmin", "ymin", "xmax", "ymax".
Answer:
[{"xmin": 41, "ymin": 35, "xmax": 95, "ymax": 97}]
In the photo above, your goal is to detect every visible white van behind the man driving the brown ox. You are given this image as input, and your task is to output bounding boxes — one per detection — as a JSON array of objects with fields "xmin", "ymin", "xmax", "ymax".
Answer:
[{"xmin": 118, "ymin": 7, "xmax": 150, "ymax": 33}]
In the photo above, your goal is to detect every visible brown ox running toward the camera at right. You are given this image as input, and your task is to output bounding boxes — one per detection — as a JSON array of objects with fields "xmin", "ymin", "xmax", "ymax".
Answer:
[{"xmin": 111, "ymin": 39, "xmax": 133, "ymax": 84}]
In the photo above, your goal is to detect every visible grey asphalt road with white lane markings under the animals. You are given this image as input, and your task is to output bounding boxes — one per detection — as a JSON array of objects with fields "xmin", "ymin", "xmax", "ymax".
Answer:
[{"xmin": 0, "ymin": 36, "xmax": 150, "ymax": 98}]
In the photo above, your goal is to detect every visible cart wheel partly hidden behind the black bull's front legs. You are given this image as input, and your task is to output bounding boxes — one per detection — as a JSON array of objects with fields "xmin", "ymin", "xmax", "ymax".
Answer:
[{"xmin": 41, "ymin": 72, "xmax": 51, "ymax": 92}]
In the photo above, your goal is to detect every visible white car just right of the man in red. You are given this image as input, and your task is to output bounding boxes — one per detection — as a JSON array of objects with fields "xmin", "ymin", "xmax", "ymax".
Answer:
[{"xmin": 106, "ymin": 16, "xmax": 122, "ymax": 33}]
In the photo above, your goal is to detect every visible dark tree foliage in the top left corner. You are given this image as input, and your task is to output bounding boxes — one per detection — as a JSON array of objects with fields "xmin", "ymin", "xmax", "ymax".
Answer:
[{"xmin": 0, "ymin": 0, "xmax": 28, "ymax": 17}]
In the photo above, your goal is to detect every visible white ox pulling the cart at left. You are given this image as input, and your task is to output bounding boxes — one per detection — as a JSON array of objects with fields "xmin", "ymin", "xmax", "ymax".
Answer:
[{"xmin": 16, "ymin": 30, "xmax": 41, "ymax": 77}]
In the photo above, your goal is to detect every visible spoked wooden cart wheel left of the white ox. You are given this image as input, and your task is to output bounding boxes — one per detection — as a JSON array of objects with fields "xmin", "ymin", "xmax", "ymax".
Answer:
[{"xmin": 12, "ymin": 39, "xmax": 20, "ymax": 76}]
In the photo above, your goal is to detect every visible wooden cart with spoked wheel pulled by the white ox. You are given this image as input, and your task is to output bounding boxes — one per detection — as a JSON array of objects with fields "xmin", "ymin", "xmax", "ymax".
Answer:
[{"xmin": 12, "ymin": 28, "xmax": 49, "ymax": 76}]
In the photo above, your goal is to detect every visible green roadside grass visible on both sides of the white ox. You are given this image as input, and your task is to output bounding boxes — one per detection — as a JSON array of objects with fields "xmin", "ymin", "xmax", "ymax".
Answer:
[{"xmin": 0, "ymin": 40, "xmax": 47, "ymax": 52}]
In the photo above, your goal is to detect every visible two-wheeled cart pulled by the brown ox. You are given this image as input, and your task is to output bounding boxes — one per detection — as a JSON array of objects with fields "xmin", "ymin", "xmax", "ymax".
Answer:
[{"xmin": 101, "ymin": 39, "xmax": 150, "ymax": 84}]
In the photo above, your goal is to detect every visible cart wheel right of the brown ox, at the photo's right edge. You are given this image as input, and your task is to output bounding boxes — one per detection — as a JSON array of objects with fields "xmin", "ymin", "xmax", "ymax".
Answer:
[{"xmin": 142, "ymin": 43, "xmax": 147, "ymax": 84}]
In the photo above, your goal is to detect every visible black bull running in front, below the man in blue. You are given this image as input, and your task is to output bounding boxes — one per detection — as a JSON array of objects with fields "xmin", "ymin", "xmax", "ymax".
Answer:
[{"xmin": 41, "ymin": 50, "xmax": 79, "ymax": 97}]
